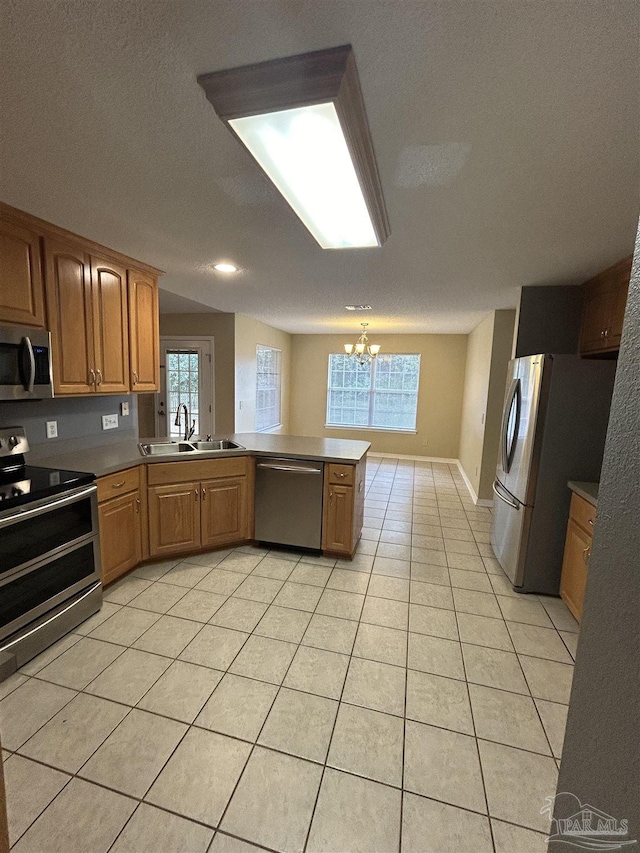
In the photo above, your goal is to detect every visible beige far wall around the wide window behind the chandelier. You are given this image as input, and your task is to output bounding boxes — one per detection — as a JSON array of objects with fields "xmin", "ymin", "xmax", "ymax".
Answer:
[{"xmin": 290, "ymin": 335, "xmax": 467, "ymax": 458}]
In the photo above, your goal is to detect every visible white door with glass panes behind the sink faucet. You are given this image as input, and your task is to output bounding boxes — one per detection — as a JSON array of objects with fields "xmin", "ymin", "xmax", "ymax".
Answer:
[{"xmin": 156, "ymin": 337, "xmax": 215, "ymax": 440}]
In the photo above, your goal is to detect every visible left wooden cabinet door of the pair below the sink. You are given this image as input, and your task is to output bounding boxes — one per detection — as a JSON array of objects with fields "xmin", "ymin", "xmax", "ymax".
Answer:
[{"xmin": 148, "ymin": 483, "xmax": 200, "ymax": 557}]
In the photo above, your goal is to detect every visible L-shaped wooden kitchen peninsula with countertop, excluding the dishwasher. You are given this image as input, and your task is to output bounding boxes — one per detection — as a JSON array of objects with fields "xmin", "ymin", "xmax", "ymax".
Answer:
[{"xmin": 36, "ymin": 433, "xmax": 370, "ymax": 585}]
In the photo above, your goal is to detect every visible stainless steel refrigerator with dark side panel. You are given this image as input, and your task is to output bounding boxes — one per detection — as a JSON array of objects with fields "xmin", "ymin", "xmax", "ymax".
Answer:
[{"xmin": 491, "ymin": 355, "xmax": 616, "ymax": 595}]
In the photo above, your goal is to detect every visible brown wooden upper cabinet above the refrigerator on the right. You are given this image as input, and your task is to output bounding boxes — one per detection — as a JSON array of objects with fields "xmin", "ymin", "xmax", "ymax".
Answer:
[{"xmin": 580, "ymin": 257, "xmax": 632, "ymax": 356}]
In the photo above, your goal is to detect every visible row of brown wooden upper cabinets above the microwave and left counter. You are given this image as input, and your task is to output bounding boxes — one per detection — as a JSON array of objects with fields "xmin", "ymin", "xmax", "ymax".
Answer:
[{"xmin": 0, "ymin": 202, "xmax": 160, "ymax": 396}]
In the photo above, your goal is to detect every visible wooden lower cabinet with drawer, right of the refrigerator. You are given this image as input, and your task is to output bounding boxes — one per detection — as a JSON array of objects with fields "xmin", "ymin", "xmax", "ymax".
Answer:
[{"xmin": 560, "ymin": 494, "xmax": 595, "ymax": 622}]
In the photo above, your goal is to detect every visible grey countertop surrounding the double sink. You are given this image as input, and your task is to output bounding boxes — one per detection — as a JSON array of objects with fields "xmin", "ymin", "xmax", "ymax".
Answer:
[{"xmin": 37, "ymin": 432, "xmax": 371, "ymax": 477}]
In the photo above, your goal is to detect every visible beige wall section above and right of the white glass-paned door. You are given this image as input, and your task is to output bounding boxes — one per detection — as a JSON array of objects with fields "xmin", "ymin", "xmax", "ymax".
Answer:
[{"xmin": 160, "ymin": 313, "xmax": 235, "ymax": 435}]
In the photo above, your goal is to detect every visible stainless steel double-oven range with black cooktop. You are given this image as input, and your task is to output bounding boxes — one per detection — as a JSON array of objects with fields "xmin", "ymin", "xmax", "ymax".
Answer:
[{"xmin": 0, "ymin": 427, "xmax": 102, "ymax": 681}]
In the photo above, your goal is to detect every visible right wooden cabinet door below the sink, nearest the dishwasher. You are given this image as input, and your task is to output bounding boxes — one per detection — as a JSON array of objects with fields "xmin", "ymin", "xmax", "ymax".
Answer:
[{"xmin": 200, "ymin": 477, "xmax": 249, "ymax": 548}]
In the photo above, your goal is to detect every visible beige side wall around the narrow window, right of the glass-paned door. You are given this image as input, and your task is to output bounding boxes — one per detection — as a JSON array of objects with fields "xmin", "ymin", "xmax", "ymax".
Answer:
[{"xmin": 235, "ymin": 314, "xmax": 291, "ymax": 433}]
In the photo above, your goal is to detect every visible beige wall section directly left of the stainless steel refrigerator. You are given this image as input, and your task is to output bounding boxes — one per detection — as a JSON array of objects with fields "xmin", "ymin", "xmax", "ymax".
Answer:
[{"xmin": 458, "ymin": 310, "xmax": 515, "ymax": 500}]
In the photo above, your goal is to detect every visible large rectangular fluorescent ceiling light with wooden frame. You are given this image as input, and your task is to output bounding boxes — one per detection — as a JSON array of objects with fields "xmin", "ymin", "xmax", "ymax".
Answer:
[{"xmin": 198, "ymin": 45, "xmax": 389, "ymax": 249}]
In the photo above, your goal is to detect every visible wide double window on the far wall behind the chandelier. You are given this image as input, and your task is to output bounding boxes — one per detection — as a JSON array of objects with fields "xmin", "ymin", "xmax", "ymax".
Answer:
[{"xmin": 327, "ymin": 354, "xmax": 420, "ymax": 430}]
